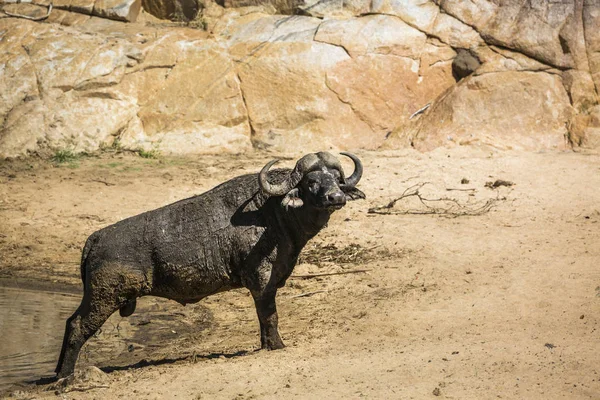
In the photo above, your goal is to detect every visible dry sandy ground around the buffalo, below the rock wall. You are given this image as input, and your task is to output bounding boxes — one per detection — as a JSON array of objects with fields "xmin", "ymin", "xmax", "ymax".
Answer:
[{"xmin": 0, "ymin": 149, "xmax": 600, "ymax": 399}]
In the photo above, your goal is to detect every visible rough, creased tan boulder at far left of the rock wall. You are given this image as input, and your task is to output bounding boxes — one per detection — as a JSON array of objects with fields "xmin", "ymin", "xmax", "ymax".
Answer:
[{"xmin": 0, "ymin": 20, "xmax": 140, "ymax": 157}]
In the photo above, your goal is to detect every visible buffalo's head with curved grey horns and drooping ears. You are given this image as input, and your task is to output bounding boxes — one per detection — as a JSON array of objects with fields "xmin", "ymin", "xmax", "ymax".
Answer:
[{"xmin": 258, "ymin": 152, "xmax": 365, "ymax": 211}]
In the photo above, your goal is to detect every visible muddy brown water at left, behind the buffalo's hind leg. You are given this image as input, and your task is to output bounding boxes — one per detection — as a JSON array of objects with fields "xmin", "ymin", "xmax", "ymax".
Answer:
[{"xmin": 0, "ymin": 287, "xmax": 81, "ymax": 388}]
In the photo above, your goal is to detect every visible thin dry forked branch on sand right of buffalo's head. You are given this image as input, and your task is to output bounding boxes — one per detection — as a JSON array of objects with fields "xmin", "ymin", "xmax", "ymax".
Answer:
[{"xmin": 368, "ymin": 182, "xmax": 506, "ymax": 218}]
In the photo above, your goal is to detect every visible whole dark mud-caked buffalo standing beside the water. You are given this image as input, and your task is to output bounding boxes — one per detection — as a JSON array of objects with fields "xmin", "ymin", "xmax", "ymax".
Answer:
[{"xmin": 56, "ymin": 152, "xmax": 365, "ymax": 377}]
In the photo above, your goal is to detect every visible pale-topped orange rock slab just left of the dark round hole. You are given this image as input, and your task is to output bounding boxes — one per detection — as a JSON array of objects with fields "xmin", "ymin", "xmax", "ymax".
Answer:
[{"xmin": 315, "ymin": 15, "xmax": 455, "ymax": 140}]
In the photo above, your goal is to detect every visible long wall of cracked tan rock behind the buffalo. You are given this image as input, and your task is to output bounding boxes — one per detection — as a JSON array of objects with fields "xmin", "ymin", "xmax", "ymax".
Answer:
[{"xmin": 0, "ymin": 0, "xmax": 600, "ymax": 157}]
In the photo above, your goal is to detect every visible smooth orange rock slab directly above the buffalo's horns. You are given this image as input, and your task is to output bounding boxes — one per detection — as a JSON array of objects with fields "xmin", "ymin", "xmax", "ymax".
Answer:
[{"xmin": 239, "ymin": 42, "xmax": 381, "ymax": 152}]
